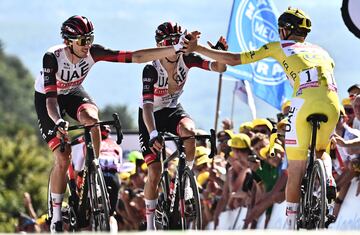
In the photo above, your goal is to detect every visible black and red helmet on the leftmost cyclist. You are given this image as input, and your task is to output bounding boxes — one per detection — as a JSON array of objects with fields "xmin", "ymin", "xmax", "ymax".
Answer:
[{"xmin": 61, "ymin": 15, "xmax": 94, "ymax": 39}]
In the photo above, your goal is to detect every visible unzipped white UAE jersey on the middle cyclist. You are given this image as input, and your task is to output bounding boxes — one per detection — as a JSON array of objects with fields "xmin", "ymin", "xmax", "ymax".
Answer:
[{"xmin": 140, "ymin": 53, "xmax": 211, "ymax": 112}]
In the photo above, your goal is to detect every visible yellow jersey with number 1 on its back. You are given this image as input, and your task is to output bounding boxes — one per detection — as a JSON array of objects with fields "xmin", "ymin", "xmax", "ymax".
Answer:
[{"xmin": 240, "ymin": 40, "xmax": 337, "ymax": 97}]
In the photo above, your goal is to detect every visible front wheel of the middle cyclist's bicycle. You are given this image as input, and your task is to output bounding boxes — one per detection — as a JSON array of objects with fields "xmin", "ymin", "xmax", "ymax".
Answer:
[{"xmin": 180, "ymin": 167, "xmax": 202, "ymax": 230}]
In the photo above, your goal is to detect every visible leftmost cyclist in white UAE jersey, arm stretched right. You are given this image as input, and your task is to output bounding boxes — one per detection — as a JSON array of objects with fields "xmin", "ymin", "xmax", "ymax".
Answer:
[{"xmin": 35, "ymin": 15, "xmax": 187, "ymax": 231}]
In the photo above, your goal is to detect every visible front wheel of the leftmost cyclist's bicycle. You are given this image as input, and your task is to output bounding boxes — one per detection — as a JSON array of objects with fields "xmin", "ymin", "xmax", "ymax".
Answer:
[{"xmin": 90, "ymin": 164, "xmax": 110, "ymax": 231}]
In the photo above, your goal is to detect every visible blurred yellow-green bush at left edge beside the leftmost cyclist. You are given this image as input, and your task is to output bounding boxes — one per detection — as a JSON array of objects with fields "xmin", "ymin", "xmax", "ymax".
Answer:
[{"xmin": 0, "ymin": 131, "xmax": 52, "ymax": 232}]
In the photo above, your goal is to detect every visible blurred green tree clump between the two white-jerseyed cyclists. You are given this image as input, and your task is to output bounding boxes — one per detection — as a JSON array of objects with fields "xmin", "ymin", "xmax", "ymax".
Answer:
[{"xmin": 99, "ymin": 105, "xmax": 135, "ymax": 130}]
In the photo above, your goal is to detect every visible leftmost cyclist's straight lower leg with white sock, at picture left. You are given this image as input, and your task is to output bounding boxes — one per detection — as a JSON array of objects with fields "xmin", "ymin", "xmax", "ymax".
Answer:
[{"xmin": 50, "ymin": 145, "xmax": 71, "ymax": 226}]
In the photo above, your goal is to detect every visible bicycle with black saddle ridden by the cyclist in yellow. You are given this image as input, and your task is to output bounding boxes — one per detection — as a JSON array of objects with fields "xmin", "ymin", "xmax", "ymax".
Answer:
[{"xmin": 297, "ymin": 114, "xmax": 333, "ymax": 229}]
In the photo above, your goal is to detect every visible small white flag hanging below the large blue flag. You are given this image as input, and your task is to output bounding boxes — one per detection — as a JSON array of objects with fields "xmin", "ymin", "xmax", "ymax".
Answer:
[{"xmin": 234, "ymin": 80, "xmax": 256, "ymax": 119}]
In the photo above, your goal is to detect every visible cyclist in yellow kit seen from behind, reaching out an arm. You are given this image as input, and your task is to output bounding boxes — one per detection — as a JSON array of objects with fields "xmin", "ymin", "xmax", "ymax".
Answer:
[{"xmin": 188, "ymin": 8, "xmax": 340, "ymax": 229}]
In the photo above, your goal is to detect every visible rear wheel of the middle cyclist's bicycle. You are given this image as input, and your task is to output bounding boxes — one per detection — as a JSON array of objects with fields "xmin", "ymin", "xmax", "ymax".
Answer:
[{"xmin": 155, "ymin": 171, "xmax": 170, "ymax": 230}]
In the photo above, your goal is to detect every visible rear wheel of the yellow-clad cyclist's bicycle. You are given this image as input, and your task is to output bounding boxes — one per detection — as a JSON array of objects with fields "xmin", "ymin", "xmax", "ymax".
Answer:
[{"xmin": 306, "ymin": 159, "xmax": 326, "ymax": 229}]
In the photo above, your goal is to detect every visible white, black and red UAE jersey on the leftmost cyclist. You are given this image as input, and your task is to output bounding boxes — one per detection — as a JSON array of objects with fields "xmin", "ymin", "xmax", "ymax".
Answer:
[{"xmin": 35, "ymin": 44, "xmax": 132, "ymax": 97}]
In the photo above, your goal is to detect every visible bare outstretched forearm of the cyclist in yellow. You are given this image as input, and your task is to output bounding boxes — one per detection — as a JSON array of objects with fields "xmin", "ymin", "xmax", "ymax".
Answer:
[{"xmin": 196, "ymin": 45, "xmax": 241, "ymax": 65}]
